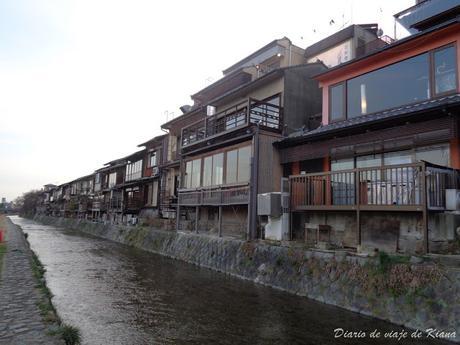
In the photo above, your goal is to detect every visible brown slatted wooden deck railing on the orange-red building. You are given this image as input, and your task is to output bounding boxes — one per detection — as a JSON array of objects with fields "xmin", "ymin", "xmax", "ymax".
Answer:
[{"xmin": 289, "ymin": 162, "xmax": 459, "ymax": 211}]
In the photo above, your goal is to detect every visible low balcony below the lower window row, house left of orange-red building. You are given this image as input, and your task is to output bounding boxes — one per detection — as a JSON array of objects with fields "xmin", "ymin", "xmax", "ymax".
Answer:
[{"xmin": 178, "ymin": 185, "xmax": 249, "ymax": 206}]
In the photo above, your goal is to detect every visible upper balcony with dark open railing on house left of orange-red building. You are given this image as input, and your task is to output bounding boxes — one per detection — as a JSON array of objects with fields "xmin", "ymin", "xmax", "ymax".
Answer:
[{"xmin": 181, "ymin": 98, "xmax": 283, "ymax": 147}]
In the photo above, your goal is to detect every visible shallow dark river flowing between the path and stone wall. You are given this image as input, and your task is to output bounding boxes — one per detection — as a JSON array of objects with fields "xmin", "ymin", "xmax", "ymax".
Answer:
[{"xmin": 11, "ymin": 217, "xmax": 452, "ymax": 345}]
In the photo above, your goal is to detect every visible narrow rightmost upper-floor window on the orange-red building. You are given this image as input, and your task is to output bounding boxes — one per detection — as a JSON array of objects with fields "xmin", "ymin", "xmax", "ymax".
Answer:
[{"xmin": 434, "ymin": 46, "xmax": 457, "ymax": 94}]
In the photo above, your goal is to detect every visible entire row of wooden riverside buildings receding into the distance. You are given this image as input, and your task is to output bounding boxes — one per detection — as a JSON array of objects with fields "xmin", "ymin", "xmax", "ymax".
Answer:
[{"xmin": 40, "ymin": 0, "xmax": 460, "ymax": 252}]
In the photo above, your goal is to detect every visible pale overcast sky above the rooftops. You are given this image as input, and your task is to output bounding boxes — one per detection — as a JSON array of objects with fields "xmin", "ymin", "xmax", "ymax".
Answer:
[{"xmin": 0, "ymin": 0, "xmax": 415, "ymax": 200}]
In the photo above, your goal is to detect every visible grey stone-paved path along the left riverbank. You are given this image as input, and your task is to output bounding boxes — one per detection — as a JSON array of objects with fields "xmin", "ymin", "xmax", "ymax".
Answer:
[{"xmin": 0, "ymin": 219, "xmax": 61, "ymax": 345}]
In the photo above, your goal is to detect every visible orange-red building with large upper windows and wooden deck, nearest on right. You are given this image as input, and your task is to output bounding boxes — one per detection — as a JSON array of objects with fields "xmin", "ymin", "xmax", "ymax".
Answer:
[{"xmin": 276, "ymin": 8, "xmax": 460, "ymax": 253}]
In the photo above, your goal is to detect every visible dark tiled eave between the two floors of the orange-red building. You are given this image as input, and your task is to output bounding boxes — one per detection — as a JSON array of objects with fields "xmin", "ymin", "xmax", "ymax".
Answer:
[{"xmin": 281, "ymin": 93, "xmax": 460, "ymax": 143}]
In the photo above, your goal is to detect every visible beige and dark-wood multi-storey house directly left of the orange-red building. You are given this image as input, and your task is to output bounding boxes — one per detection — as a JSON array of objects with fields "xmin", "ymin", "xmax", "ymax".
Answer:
[{"xmin": 175, "ymin": 39, "xmax": 326, "ymax": 238}]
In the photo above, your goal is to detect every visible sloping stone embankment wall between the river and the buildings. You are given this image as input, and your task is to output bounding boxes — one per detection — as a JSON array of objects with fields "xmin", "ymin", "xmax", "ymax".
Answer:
[{"xmin": 35, "ymin": 216, "xmax": 460, "ymax": 342}]
